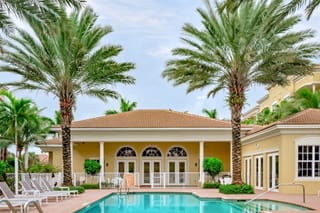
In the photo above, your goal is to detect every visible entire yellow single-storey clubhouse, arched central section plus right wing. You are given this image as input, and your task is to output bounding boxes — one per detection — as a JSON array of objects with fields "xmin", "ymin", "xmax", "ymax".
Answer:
[{"xmin": 41, "ymin": 109, "xmax": 320, "ymax": 194}]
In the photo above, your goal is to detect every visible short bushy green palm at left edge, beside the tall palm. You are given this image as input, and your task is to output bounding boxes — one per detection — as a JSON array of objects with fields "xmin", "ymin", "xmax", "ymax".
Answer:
[{"xmin": 0, "ymin": 91, "xmax": 52, "ymax": 169}]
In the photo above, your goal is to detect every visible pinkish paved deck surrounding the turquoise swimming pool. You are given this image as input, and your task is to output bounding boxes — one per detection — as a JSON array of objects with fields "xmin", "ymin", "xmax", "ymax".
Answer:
[{"xmin": 0, "ymin": 188, "xmax": 320, "ymax": 213}]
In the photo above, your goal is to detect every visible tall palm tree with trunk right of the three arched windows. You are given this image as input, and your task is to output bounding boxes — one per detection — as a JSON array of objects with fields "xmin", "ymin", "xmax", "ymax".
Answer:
[{"xmin": 162, "ymin": 0, "xmax": 320, "ymax": 184}]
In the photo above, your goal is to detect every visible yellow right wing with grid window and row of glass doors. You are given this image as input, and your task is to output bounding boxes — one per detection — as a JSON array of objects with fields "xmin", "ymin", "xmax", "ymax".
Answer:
[{"xmin": 242, "ymin": 109, "xmax": 320, "ymax": 194}]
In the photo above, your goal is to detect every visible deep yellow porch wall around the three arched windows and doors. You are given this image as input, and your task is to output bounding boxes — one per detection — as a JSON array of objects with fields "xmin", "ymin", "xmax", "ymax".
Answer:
[{"xmin": 73, "ymin": 142, "xmax": 230, "ymax": 172}]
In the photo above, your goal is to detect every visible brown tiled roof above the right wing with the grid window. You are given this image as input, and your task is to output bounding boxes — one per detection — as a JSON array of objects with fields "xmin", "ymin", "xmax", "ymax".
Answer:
[{"xmin": 247, "ymin": 109, "xmax": 320, "ymax": 135}]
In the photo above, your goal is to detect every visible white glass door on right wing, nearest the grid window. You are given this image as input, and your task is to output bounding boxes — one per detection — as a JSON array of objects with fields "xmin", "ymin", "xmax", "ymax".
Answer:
[{"xmin": 268, "ymin": 153, "xmax": 279, "ymax": 191}]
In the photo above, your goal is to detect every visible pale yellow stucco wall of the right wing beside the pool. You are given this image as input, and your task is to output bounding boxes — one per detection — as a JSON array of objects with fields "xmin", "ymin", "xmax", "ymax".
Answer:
[{"xmin": 242, "ymin": 134, "xmax": 320, "ymax": 194}]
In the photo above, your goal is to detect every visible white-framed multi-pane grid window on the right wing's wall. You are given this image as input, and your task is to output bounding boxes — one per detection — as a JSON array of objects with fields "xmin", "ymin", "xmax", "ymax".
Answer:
[{"xmin": 297, "ymin": 145, "xmax": 320, "ymax": 177}]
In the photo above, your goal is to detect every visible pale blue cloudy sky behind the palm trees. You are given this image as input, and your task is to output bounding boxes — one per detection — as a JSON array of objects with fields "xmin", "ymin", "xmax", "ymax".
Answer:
[{"xmin": 0, "ymin": 0, "xmax": 320, "ymax": 120}]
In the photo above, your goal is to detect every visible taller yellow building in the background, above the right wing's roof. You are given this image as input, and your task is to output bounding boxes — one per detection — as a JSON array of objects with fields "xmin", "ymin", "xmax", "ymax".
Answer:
[{"xmin": 243, "ymin": 65, "xmax": 320, "ymax": 120}]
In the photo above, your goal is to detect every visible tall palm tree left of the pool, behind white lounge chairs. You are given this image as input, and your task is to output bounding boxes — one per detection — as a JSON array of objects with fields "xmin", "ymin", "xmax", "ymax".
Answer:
[{"xmin": 0, "ymin": 8, "xmax": 135, "ymax": 185}]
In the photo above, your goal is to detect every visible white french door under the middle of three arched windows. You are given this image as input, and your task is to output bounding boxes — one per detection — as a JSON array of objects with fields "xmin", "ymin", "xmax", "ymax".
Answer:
[{"xmin": 142, "ymin": 160, "xmax": 161, "ymax": 185}]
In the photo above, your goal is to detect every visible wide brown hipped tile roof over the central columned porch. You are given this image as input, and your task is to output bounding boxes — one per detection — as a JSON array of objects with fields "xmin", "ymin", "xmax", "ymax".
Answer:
[{"xmin": 71, "ymin": 110, "xmax": 231, "ymax": 128}]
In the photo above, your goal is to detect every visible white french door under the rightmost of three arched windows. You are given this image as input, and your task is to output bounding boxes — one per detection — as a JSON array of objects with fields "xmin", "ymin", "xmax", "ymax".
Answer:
[{"xmin": 168, "ymin": 160, "xmax": 186, "ymax": 185}]
